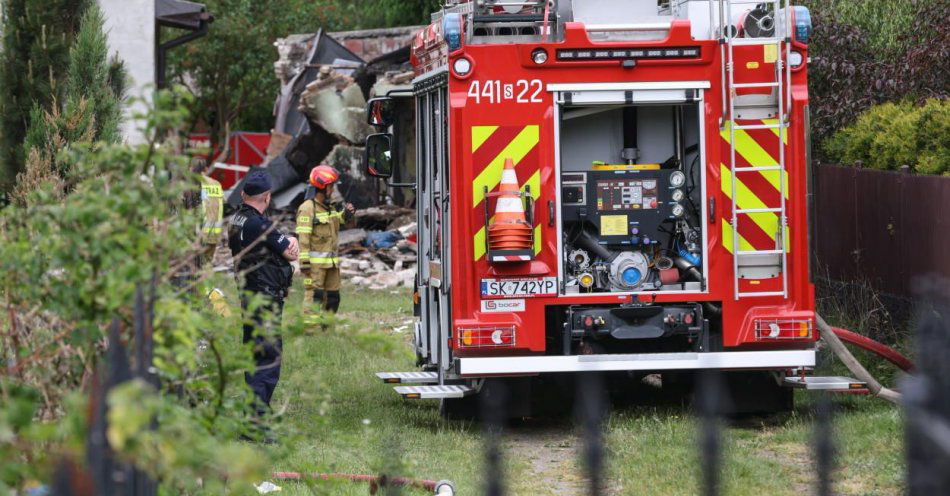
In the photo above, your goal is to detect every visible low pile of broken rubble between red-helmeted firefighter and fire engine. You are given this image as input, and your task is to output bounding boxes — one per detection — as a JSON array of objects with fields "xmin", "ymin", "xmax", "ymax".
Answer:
[{"xmin": 339, "ymin": 206, "xmax": 418, "ymax": 289}]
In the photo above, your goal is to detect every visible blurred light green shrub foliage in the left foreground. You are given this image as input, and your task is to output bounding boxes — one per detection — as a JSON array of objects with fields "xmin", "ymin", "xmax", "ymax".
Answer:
[{"xmin": 0, "ymin": 88, "xmax": 282, "ymax": 494}]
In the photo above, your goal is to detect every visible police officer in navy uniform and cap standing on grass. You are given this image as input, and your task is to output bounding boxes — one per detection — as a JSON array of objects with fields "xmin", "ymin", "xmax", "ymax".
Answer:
[{"xmin": 228, "ymin": 170, "xmax": 299, "ymax": 415}]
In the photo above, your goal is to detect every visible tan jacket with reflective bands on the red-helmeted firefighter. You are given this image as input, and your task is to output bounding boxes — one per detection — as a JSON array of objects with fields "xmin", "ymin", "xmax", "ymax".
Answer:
[{"xmin": 297, "ymin": 199, "xmax": 345, "ymax": 268}]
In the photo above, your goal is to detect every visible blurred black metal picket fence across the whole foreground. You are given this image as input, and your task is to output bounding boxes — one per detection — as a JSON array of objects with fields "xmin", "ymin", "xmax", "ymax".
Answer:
[{"xmin": 53, "ymin": 278, "xmax": 950, "ymax": 496}]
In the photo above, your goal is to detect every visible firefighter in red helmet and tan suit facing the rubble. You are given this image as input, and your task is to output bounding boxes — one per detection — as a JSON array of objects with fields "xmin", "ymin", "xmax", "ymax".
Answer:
[{"xmin": 297, "ymin": 165, "xmax": 353, "ymax": 325}]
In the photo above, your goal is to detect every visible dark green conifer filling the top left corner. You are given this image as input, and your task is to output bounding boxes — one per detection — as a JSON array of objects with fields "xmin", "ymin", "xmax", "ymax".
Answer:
[{"xmin": 0, "ymin": 0, "xmax": 91, "ymax": 197}]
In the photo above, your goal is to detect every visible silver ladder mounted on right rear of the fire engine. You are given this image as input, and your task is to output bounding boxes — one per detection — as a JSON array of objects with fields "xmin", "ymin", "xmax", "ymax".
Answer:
[{"xmin": 710, "ymin": 0, "xmax": 792, "ymax": 300}]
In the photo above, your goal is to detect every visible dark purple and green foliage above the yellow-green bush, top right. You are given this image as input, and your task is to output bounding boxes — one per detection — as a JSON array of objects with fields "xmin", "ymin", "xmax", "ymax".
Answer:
[{"xmin": 804, "ymin": 0, "xmax": 950, "ymax": 151}]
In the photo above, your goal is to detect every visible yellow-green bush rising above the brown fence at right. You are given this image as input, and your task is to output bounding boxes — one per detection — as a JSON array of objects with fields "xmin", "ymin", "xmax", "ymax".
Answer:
[{"xmin": 825, "ymin": 98, "xmax": 950, "ymax": 174}]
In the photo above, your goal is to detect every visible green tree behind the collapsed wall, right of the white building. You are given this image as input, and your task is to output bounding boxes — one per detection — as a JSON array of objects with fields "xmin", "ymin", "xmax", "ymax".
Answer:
[{"xmin": 167, "ymin": 0, "xmax": 439, "ymax": 143}]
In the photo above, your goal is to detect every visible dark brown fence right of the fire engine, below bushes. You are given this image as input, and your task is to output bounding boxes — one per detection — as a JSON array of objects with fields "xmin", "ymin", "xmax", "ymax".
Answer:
[{"xmin": 812, "ymin": 165, "xmax": 950, "ymax": 297}]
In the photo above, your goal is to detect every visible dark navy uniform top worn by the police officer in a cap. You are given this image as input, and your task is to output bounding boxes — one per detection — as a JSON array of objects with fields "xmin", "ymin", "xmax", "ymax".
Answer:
[{"xmin": 228, "ymin": 203, "xmax": 294, "ymax": 298}]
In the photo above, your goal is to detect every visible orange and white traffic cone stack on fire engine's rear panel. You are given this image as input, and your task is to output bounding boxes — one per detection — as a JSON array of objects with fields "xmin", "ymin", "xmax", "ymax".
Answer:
[{"xmin": 488, "ymin": 158, "xmax": 534, "ymax": 251}]
